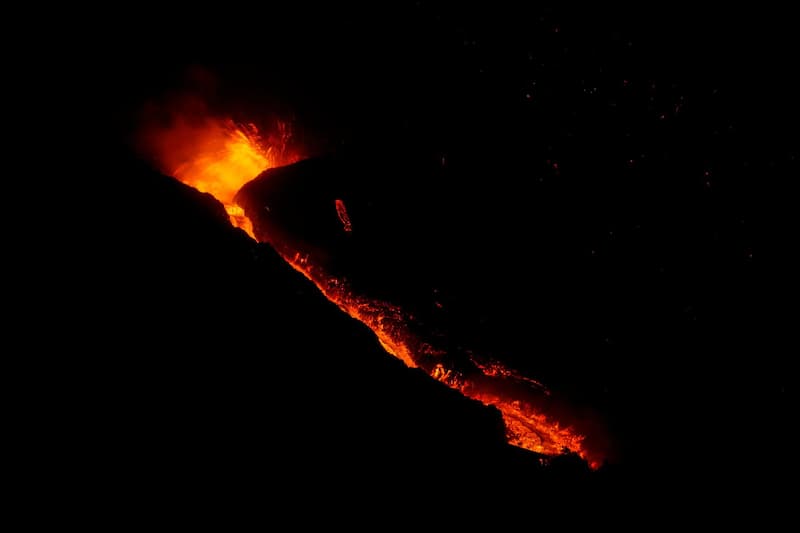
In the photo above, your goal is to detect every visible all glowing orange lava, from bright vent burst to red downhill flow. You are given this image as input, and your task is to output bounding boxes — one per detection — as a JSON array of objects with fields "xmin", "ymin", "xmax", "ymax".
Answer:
[{"xmin": 145, "ymin": 118, "xmax": 600, "ymax": 468}]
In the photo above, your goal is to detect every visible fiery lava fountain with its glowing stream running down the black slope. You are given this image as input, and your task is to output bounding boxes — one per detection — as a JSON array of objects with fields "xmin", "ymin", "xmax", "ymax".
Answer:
[{"xmin": 143, "ymin": 111, "xmax": 602, "ymax": 468}]
